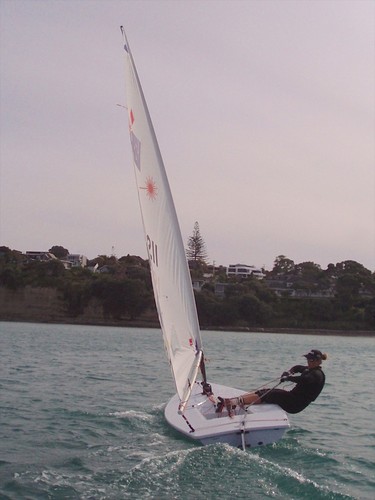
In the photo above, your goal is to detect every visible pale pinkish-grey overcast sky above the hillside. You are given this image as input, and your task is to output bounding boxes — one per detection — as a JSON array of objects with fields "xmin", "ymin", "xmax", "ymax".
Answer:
[{"xmin": 0, "ymin": 0, "xmax": 375, "ymax": 271}]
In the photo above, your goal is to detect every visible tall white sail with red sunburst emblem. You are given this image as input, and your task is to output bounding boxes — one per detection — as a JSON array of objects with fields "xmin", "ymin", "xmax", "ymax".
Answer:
[{"xmin": 122, "ymin": 30, "xmax": 202, "ymax": 411}]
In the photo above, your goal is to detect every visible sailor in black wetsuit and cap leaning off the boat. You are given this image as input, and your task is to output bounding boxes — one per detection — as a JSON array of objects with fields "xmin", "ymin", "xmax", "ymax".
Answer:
[{"xmin": 216, "ymin": 349, "xmax": 327, "ymax": 417}]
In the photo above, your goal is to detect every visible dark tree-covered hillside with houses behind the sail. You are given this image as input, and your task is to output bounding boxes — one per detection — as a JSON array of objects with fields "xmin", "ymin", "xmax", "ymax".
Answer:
[{"xmin": 0, "ymin": 247, "xmax": 375, "ymax": 333}]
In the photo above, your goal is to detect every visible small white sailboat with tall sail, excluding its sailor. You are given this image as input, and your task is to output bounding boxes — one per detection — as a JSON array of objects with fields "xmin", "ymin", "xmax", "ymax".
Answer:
[{"xmin": 121, "ymin": 27, "xmax": 289, "ymax": 449}]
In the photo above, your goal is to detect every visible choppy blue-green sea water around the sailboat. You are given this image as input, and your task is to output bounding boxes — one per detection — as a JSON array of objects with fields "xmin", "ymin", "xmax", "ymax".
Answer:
[{"xmin": 0, "ymin": 322, "xmax": 375, "ymax": 500}]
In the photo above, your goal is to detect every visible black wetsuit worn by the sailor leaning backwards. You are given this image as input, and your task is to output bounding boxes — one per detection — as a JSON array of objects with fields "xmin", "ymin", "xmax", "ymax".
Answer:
[{"xmin": 257, "ymin": 365, "xmax": 325, "ymax": 413}]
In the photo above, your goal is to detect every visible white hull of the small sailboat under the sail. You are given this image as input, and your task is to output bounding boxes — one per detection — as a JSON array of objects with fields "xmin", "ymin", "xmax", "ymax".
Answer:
[{"xmin": 164, "ymin": 382, "xmax": 289, "ymax": 449}]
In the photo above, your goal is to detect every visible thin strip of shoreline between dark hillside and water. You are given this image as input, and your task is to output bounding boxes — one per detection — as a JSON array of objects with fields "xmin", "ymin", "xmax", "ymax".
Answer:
[{"xmin": 0, "ymin": 318, "xmax": 375, "ymax": 337}]
